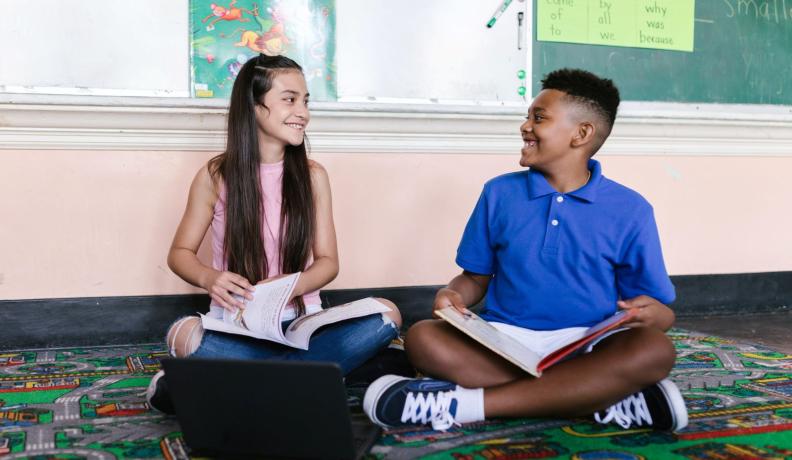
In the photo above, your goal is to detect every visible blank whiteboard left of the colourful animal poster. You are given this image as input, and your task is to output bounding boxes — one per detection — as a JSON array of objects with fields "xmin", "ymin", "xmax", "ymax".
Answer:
[{"xmin": 0, "ymin": 0, "xmax": 190, "ymax": 97}]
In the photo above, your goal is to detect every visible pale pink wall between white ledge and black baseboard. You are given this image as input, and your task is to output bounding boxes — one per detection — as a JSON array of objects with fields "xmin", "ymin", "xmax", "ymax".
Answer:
[{"xmin": 0, "ymin": 150, "xmax": 792, "ymax": 299}]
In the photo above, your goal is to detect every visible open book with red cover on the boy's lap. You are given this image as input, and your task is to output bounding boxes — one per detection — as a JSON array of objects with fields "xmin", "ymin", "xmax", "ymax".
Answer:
[{"xmin": 436, "ymin": 307, "xmax": 636, "ymax": 377}]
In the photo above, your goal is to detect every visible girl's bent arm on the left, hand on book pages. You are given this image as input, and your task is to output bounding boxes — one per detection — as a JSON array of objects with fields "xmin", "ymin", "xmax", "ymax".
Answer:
[{"xmin": 168, "ymin": 166, "xmax": 253, "ymax": 308}]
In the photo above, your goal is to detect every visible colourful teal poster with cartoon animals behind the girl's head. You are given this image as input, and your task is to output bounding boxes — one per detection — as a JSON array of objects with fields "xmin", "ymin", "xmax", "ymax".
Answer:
[{"xmin": 190, "ymin": 0, "xmax": 336, "ymax": 101}]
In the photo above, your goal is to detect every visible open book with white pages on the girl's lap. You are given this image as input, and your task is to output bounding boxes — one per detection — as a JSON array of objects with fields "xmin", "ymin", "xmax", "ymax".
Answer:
[{"xmin": 201, "ymin": 273, "xmax": 388, "ymax": 350}]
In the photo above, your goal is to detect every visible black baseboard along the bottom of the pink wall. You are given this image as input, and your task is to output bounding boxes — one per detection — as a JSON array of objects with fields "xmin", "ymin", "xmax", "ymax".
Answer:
[{"xmin": 0, "ymin": 272, "xmax": 792, "ymax": 350}]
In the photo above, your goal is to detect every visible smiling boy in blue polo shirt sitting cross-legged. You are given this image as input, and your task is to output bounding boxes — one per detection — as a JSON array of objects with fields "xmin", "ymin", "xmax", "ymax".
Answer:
[{"xmin": 363, "ymin": 69, "xmax": 687, "ymax": 430}]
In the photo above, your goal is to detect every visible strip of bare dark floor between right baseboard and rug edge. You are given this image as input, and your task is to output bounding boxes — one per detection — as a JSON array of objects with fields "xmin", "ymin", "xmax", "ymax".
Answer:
[{"xmin": 674, "ymin": 310, "xmax": 792, "ymax": 355}]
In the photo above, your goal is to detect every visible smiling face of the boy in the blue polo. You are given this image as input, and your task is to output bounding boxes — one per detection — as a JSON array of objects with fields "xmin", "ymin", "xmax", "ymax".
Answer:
[{"xmin": 520, "ymin": 89, "xmax": 579, "ymax": 172}]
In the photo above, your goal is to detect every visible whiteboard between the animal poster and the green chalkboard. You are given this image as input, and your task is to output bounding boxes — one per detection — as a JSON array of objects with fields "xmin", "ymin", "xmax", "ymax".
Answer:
[{"xmin": 336, "ymin": 0, "xmax": 531, "ymax": 103}]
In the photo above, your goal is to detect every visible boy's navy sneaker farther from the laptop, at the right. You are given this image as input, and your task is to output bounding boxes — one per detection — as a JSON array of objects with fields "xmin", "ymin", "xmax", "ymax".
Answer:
[{"xmin": 594, "ymin": 379, "xmax": 688, "ymax": 431}]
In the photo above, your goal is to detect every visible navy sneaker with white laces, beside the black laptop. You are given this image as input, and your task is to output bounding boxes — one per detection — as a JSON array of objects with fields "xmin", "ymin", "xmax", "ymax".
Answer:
[{"xmin": 363, "ymin": 375, "xmax": 458, "ymax": 431}]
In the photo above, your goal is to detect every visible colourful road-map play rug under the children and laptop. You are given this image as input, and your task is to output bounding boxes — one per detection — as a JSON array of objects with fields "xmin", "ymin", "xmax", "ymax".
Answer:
[{"xmin": 0, "ymin": 331, "xmax": 792, "ymax": 460}]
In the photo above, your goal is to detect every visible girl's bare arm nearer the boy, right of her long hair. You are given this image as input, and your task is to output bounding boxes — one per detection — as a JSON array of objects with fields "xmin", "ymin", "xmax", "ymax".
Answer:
[{"xmin": 293, "ymin": 161, "xmax": 338, "ymax": 296}]
